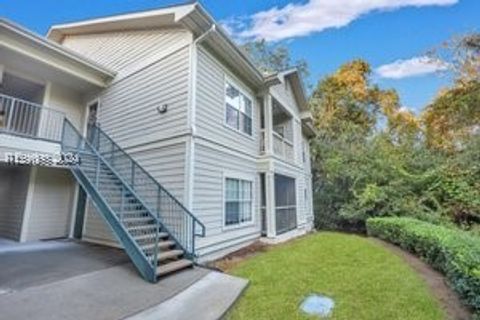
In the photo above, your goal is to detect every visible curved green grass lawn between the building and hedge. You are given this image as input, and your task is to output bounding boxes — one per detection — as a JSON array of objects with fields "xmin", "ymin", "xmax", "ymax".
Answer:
[{"xmin": 228, "ymin": 233, "xmax": 444, "ymax": 320}]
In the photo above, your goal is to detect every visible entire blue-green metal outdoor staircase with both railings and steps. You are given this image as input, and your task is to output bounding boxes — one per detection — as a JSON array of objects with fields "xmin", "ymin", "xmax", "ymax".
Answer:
[{"xmin": 62, "ymin": 119, "xmax": 205, "ymax": 282}]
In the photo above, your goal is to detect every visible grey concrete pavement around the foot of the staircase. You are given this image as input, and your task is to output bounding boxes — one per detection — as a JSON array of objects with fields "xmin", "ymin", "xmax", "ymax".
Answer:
[{"xmin": 0, "ymin": 243, "xmax": 247, "ymax": 320}]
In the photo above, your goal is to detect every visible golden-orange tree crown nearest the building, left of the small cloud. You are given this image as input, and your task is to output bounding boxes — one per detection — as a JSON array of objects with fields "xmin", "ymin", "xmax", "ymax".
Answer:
[{"xmin": 310, "ymin": 60, "xmax": 419, "ymax": 137}]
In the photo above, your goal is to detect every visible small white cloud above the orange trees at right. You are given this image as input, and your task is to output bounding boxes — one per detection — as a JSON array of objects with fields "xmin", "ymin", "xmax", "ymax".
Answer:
[{"xmin": 375, "ymin": 56, "xmax": 448, "ymax": 79}]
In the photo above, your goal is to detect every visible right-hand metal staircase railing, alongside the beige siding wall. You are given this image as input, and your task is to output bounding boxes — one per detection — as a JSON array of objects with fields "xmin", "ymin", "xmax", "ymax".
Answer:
[{"xmin": 88, "ymin": 125, "xmax": 205, "ymax": 259}]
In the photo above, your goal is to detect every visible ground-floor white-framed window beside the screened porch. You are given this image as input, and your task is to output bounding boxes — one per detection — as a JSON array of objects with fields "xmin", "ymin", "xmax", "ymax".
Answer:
[{"xmin": 225, "ymin": 178, "xmax": 253, "ymax": 226}]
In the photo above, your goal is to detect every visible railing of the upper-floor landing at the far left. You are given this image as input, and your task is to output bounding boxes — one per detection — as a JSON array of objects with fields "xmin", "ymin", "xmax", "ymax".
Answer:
[{"xmin": 0, "ymin": 94, "xmax": 65, "ymax": 142}]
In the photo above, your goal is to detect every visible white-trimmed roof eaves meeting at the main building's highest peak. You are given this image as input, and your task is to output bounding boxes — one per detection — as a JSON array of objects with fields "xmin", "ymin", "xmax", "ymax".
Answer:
[{"xmin": 47, "ymin": 2, "xmax": 264, "ymax": 87}]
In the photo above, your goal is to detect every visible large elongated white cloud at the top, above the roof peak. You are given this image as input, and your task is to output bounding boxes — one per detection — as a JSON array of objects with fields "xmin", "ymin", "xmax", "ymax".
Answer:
[{"xmin": 229, "ymin": 0, "xmax": 459, "ymax": 41}]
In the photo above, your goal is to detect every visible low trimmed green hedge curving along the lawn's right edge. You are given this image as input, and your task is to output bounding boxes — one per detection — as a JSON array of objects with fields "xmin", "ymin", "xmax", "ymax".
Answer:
[{"xmin": 367, "ymin": 218, "xmax": 480, "ymax": 319}]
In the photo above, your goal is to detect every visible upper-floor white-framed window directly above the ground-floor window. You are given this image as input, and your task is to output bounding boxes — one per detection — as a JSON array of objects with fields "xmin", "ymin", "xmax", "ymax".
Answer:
[{"xmin": 225, "ymin": 82, "xmax": 252, "ymax": 136}]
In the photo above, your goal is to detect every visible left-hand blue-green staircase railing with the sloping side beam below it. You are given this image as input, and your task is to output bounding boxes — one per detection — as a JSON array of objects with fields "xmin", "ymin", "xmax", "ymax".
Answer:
[{"xmin": 61, "ymin": 119, "xmax": 161, "ymax": 282}]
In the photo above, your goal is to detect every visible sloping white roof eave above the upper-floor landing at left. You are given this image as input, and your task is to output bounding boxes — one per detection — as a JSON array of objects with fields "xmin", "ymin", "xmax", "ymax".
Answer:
[{"xmin": 0, "ymin": 18, "xmax": 115, "ymax": 86}]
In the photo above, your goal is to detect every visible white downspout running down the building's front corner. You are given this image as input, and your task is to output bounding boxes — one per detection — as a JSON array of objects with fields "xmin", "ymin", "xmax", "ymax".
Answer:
[{"xmin": 185, "ymin": 24, "xmax": 217, "ymax": 210}]
